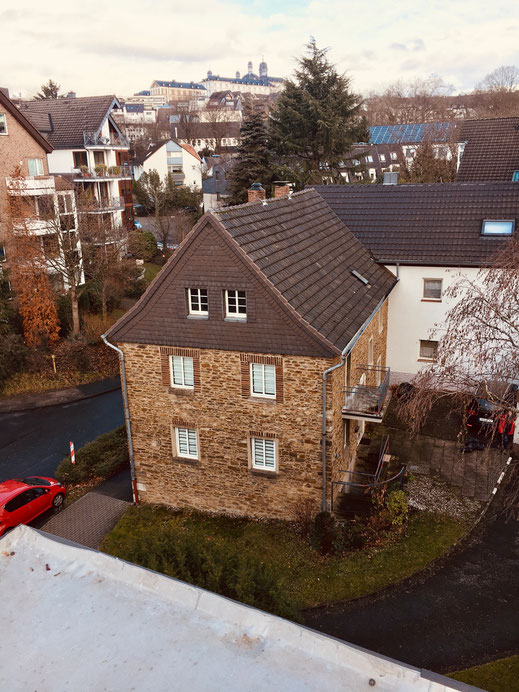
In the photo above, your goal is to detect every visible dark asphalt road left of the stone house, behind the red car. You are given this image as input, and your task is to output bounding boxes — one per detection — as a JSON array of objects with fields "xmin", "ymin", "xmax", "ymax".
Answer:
[{"xmin": 0, "ymin": 390, "xmax": 124, "ymax": 482}]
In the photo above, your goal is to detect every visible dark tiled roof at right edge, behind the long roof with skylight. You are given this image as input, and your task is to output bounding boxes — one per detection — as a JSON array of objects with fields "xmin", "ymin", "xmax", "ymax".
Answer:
[{"xmin": 456, "ymin": 117, "xmax": 519, "ymax": 183}]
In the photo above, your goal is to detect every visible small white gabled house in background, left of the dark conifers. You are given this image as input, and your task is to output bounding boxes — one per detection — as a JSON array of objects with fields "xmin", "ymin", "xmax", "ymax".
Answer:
[{"xmin": 132, "ymin": 139, "xmax": 202, "ymax": 189}]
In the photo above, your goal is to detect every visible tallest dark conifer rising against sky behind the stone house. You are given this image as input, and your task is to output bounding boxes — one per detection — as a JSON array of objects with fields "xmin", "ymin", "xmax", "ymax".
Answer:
[{"xmin": 270, "ymin": 40, "xmax": 369, "ymax": 183}]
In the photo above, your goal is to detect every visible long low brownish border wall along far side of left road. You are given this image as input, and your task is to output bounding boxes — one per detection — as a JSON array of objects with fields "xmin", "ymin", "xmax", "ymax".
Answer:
[{"xmin": 0, "ymin": 377, "xmax": 121, "ymax": 414}]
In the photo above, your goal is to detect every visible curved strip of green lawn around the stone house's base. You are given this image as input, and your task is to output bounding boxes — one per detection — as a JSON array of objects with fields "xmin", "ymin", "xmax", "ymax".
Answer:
[{"xmin": 102, "ymin": 505, "xmax": 467, "ymax": 608}]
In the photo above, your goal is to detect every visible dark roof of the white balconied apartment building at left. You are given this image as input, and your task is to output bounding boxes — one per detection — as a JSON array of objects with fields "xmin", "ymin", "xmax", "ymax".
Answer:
[{"xmin": 20, "ymin": 96, "xmax": 120, "ymax": 149}]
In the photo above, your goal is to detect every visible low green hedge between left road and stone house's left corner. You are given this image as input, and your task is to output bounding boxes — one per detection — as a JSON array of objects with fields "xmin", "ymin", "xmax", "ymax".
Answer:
[{"xmin": 54, "ymin": 425, "xmax": 129, "ymax": 485}]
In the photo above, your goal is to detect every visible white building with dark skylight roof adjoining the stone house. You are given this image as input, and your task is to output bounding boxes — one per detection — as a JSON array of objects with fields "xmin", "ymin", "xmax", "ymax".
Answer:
[{"xmin": 316, "ymin": 182, "xmax": 519, "ymax": 382}]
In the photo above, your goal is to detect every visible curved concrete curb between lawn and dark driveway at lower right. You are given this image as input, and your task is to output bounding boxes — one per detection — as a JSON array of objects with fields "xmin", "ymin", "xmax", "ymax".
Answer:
[{"xmin": 301, "ymin": 456, "xmax": 512, "ymax": 617}]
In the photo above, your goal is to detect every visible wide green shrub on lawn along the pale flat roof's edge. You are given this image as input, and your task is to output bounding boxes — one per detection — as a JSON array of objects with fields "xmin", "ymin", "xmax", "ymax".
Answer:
[{"xmin": 117, "ymin": 524, "xmax": 298, "ymax": 619}]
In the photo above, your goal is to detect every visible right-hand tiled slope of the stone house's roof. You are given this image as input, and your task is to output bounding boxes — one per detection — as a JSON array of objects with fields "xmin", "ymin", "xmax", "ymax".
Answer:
[{"xmin": 213, "ymin": 190, "xmax": 395, "ymax": 350}]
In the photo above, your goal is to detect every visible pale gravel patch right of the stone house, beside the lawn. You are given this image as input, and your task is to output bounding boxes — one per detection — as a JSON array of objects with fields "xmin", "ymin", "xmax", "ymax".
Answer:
[{"xmin": 406, "ymin": 476, "xmax": 482, "ymax": 521}]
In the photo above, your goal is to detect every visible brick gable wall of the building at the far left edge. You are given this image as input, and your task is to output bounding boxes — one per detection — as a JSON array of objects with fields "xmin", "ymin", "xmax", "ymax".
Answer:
[{"xmin": 0, "ymin": 107, "xmax": 49, "ymax": 242}]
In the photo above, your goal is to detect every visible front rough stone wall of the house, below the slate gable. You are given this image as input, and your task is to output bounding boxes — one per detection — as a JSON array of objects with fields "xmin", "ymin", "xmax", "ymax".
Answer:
[{"xmin": 120, "ymin": 343, "xmax": 338, "ymax": 519}]
